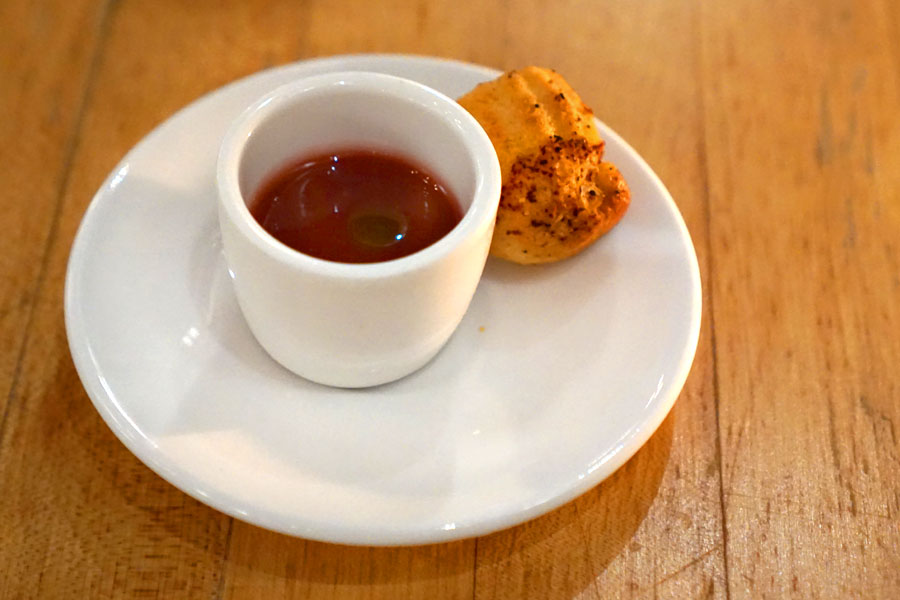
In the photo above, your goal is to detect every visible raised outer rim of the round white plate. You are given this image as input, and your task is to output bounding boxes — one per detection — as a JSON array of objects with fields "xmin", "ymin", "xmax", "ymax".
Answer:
[{"xmin": 63, "ymin": 53, "xmax": 702, "ymax": 546}]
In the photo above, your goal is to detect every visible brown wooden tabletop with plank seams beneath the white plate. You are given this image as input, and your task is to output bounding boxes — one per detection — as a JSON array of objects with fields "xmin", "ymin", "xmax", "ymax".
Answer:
[{"xmin": 0, "ymin": 0, "xmax": 900, "ymax": 600}]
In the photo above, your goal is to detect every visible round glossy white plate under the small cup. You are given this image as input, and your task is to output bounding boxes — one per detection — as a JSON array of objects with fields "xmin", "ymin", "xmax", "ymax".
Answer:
[{"xmin": 65, "ymin": 55, "xmax": 700, "ymax": 545}]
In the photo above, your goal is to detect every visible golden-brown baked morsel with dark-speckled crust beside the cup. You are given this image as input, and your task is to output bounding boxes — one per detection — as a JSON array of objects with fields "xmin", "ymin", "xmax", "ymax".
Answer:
[{"xmin": 459, "ymin": 67, "xmax": 630, "ymax": 264}]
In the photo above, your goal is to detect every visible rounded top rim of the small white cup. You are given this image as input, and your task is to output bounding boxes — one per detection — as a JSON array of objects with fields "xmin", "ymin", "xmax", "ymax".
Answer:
[{"xmin": 216, "ymin": 71, "xmax": 501, "ymax": 280}]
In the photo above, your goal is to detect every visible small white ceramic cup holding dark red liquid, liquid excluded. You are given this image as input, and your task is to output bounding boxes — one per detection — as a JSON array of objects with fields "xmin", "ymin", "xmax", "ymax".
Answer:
[{"xmin": 217, "ymin": 72, "xmax": 500, "ymax": 387}]
